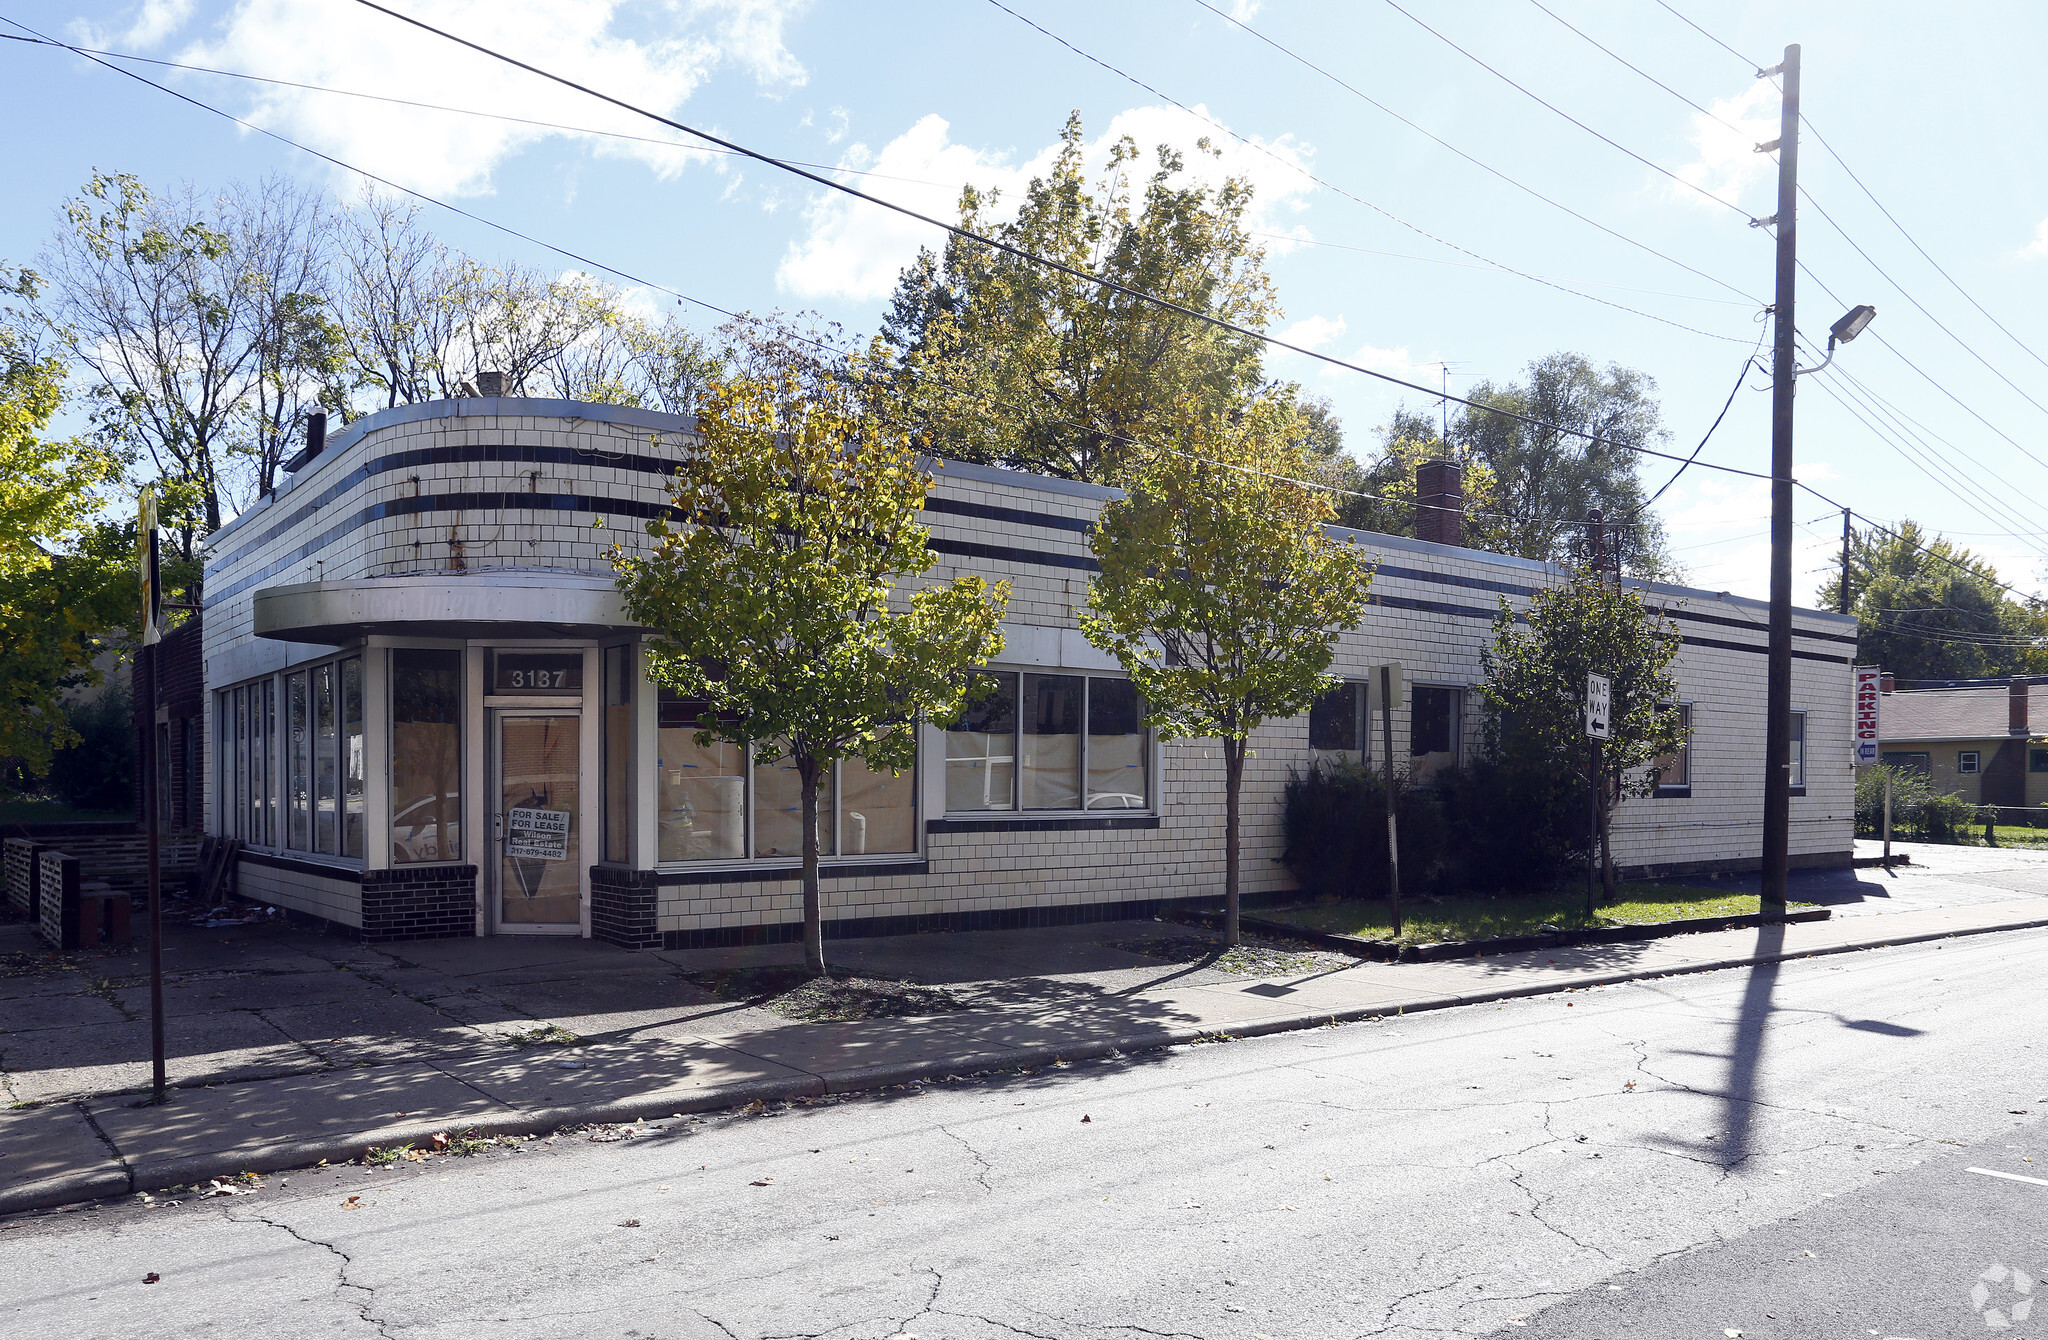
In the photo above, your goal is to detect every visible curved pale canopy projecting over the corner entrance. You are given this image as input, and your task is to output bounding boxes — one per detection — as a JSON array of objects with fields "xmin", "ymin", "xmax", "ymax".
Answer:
[{"xmin": 254, "ymin": 572, "xmax": 635, "ymax": 645}]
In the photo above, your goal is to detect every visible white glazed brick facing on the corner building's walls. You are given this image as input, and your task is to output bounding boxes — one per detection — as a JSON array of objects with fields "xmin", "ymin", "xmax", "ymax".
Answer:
[{"xmin": 205, "ymin": 402, "xmax": 1853, "ymax": 930}]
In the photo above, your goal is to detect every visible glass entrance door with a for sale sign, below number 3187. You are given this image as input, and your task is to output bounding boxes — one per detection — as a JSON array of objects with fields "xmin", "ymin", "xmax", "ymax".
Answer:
[{"xmin": 492, "ymin": 711, "xmax": 584, "ymax": 932}]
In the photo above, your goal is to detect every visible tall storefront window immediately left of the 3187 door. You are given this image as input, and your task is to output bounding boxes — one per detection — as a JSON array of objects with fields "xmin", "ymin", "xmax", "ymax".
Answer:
[{"xmin": 391, "ymin": 647, "xmax": 463, "ymax": 865}]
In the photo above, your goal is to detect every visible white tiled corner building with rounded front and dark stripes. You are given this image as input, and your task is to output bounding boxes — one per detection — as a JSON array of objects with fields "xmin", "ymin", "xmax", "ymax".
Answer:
[{"xmin": 205, "ymin": 397, "xmax": 1855, "ymax": 947}]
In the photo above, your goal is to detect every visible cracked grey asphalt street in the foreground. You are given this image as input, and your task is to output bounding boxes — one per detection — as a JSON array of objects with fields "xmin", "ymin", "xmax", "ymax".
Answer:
[{"xmin": 0, "ymin": 932, "xmax": 2048, "ymax": 1340}]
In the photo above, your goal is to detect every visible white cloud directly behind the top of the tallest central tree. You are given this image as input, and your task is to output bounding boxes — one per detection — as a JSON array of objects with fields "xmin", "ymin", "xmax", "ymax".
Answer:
[{"xmin": 776, "ymin": 107, "xmax": 1313, "ymax": 299}]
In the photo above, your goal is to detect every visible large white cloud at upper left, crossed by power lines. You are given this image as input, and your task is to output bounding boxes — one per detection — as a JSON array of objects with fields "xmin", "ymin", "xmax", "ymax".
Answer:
[{"xmin": 182, "ymin": 0, "xmax": 805, "ymax": 195}]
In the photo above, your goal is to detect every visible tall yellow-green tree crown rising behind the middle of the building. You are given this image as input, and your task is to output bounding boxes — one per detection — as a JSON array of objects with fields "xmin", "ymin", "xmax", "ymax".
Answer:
[{"xmin": 883, "ymin": 113, "xmax": 1278, "ymax": 481}]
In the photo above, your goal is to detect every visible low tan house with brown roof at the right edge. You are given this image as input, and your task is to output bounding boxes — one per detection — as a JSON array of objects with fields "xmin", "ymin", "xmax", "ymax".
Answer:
[{"xmin": 1878, "ymin": 676, "xmax": 2048, "ymax": 807}]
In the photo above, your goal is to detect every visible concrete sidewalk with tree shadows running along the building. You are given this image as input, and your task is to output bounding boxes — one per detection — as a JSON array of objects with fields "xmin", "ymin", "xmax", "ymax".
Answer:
[{"xmin": 0, "ymin": 848, "xmax": 2048, "ymax": 1211}]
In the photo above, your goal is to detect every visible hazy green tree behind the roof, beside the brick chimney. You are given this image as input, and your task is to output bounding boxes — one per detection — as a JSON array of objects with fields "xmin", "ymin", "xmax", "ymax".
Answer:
[{"xmin": 1368, "ymin": 352, "xmax": 1671, "ymax": 578}]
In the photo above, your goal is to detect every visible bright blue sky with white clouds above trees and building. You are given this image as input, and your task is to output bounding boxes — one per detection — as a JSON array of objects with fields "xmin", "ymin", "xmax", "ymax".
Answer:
[{"xmin": 0, "ymin": 0, "xmax": 2048, "ymax": 598}]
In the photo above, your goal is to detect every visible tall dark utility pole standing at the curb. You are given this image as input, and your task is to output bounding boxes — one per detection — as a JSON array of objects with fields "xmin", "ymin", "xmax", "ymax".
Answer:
[{"xmin": 1757, "ymin": 43, "xmax": 1798, "ymax": 916}]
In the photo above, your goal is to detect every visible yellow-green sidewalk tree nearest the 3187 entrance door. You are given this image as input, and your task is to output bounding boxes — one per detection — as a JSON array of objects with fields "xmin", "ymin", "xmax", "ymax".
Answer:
[{"xmin": 612, "ymin": 350, "xmax": 1010, "ymax": 975}]
